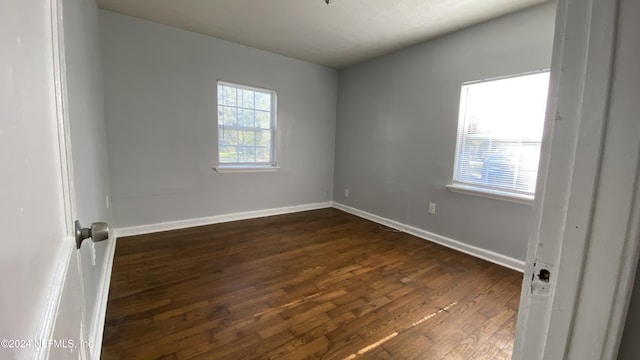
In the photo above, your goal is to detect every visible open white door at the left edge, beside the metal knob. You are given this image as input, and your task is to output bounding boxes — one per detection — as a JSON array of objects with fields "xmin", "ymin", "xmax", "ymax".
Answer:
[{"xmin": 0, "ymin": 0, "xmax": 99, "ymax": 359}]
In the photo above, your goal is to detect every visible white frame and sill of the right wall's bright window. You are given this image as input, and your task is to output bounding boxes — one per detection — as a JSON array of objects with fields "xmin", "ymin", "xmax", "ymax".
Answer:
[{"xmin": 447, "ymin": 69, "xmax": 549, "ymax": 205}]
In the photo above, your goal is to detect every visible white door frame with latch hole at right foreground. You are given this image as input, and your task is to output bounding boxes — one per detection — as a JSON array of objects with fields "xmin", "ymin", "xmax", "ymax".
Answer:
[{"xmin": 514, "ymin": 0, "xmax": 640, "ymax": 360}]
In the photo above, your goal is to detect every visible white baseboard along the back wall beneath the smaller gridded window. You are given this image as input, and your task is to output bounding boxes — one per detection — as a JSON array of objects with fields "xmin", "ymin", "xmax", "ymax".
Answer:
[{"xmin": 116, "ymin": 201, "xmax": 333, "ymax": 238}]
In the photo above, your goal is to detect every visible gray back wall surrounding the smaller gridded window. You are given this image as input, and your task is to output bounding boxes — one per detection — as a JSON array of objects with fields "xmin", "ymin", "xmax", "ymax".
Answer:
[{"xmin": 100, "ymin": 11, "xmax": 337, "ymax": 227}]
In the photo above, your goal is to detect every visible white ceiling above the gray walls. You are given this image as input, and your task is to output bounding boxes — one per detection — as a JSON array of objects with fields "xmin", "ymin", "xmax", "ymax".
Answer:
[{"xmin": 98, "ymin": 0, "xmax": 546, "ymax": 68}]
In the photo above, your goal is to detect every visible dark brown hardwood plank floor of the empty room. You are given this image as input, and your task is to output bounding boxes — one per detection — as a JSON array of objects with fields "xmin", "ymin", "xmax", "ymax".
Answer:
[{"xmin": 102, "ymin": 209, "xmax": 522, "ymax": 360}]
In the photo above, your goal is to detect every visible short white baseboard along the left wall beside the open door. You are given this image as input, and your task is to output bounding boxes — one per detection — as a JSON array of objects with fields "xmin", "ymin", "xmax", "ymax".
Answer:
[{"xmin": 89, "ymin": 235, "xmax": 118, "ymax": 360}]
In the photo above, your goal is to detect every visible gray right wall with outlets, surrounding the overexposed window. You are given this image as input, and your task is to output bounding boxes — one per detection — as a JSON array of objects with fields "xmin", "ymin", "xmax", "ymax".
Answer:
[{"xmin": 334, "ymin": 3, "xmax": 555, "ymax": 260}]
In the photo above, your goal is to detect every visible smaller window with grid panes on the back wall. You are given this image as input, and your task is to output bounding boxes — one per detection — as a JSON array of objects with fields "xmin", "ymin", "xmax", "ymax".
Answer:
[{"xmin": 216, "ymin": 81, "xmax": 276, "ymax": 171}]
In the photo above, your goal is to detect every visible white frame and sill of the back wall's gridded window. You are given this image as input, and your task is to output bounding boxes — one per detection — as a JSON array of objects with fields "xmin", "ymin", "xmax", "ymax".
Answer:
[{"xmin": 214, "ymin": 80, "xmax": 279, "ymax": 173}]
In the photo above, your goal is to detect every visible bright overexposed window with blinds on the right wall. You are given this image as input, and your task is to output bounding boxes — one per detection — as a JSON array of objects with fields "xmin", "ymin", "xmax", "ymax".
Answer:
[{"xmin": 449, "ymin": 71, "xmax": 549, "ymax": 203}]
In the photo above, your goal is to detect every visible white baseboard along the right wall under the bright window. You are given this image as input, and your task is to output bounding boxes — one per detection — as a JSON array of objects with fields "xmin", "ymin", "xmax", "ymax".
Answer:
[{"xmin": 333, "ymin": 202, "xmax": 525, "ymax": 272}]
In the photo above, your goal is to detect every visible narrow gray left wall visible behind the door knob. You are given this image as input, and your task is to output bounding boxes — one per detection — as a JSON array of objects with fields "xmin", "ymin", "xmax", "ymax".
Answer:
[{"xmin": 63, "ymin": 0, "xmax": 113, "ymax": 331}]
